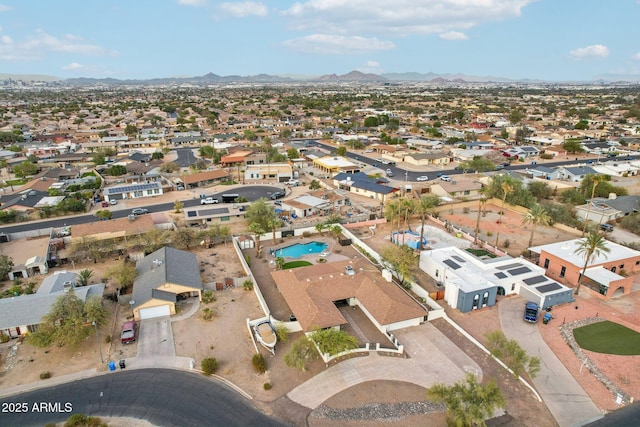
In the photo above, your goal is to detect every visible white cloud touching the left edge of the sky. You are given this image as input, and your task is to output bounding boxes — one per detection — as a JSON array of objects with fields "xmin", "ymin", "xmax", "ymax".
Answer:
[{"xmin": 0, "ymin": 29, "xmax": 117, "ymax": 61}]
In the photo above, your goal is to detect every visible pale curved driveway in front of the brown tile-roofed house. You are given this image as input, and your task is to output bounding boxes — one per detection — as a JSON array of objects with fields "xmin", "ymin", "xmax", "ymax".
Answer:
[{"xmin": 287, "ymin": 323, "xmax": 482, "ymax": 409}]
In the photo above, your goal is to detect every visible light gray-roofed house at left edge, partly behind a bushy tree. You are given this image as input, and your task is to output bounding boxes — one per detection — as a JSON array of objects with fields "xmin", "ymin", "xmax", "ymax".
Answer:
[{"xmin": 0, "ymin": 271, "xmax": 104, "ymax": 338}]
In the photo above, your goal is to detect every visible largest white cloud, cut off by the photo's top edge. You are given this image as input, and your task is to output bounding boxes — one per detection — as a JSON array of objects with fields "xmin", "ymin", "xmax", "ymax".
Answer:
[{"xmin": 282, "ymin": 0, "xmax": 535, "ymax": 37}]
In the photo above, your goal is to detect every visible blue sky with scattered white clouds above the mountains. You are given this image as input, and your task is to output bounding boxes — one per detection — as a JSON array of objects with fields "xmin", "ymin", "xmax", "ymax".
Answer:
[{"xmin": 0, "ymin": 0, "xmax": 640, "ymax": 81}]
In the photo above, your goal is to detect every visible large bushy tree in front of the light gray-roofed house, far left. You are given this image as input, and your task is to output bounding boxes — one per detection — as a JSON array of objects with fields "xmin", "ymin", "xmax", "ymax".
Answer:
[{"xmin": 27, "ymin": 290, "xmax": 109, "ymax": 347}]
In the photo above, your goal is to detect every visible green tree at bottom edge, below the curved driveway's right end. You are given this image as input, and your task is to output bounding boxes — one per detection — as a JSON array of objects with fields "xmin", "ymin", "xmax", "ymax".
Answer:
[{"xmin": 427, "ymin": 372, "xmax": 507, "ymax": 427}]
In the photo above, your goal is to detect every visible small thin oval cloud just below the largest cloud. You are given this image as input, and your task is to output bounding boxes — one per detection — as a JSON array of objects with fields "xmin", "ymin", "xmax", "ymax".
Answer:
[{"xmin": 284, "ymin": 34, "xmax": 395, "ymax": 55}]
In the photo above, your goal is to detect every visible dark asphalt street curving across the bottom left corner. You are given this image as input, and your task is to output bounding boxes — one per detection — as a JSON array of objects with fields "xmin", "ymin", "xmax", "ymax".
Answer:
[{"xmin": 0, "ymin": 369, "xmax": 285, "ymax": 427}]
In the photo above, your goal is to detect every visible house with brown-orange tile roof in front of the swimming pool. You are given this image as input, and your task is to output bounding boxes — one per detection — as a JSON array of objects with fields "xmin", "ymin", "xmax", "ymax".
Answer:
[{"xmin": 271, "ymin": 261, "xmax": 428, "ymax": 332}]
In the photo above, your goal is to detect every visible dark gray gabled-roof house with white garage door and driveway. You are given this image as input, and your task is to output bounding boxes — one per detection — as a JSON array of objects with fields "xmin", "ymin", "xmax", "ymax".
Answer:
[{"xmin": 131, "ymin": 246, "xmax": 203, "ymax": 320}]
